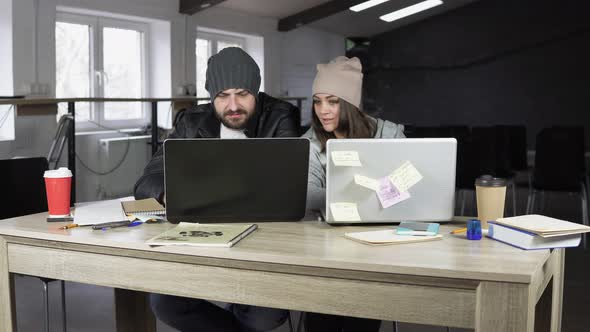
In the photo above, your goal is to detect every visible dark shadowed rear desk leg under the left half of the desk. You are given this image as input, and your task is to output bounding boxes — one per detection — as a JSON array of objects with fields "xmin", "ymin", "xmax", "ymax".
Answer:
[{"xmin": 115, "ymin": 288, "xmax": 156, "ymax": 332}]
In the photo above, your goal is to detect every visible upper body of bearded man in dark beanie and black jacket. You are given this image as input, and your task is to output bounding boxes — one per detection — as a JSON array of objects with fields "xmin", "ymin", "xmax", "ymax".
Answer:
[{"xmin": 134, "ymin": 47, "xmax": 299, "ymax": 203}]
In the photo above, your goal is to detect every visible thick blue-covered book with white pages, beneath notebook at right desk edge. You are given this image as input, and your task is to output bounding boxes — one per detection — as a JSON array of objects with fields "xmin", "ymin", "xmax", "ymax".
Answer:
[{"xmin": 488, "ymin": 221, "xmax": 581, "ymax": 250}]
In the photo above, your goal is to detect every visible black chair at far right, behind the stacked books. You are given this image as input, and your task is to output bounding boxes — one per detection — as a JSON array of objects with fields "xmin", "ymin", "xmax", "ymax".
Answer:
[{"xmin": 527, "ymin": 127, "xmax": 589, "ymax": 248}]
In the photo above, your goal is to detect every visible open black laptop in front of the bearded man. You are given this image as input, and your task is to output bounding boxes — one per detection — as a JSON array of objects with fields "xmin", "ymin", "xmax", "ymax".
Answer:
[{"xmin": 164, "ymin": 138, "xmax": 309, "ymax": 223}]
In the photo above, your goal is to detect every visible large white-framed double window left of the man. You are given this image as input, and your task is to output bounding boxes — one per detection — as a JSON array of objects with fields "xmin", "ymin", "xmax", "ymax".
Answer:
[{"xmin": 55, "ymin": 13, "xmax": 149, "ymax": 128}]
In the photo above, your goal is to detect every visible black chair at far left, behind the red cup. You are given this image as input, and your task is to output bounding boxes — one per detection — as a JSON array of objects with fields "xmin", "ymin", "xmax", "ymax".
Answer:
[{"xmin": 0, "ymin": 157, "xmax": 66, "ymax": 331}]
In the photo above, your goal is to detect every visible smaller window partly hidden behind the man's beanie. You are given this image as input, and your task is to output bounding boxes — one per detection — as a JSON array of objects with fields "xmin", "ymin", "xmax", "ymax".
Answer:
[{"xmin": 195, "ymin": 31, "xmax": 246, "ymax": 103}]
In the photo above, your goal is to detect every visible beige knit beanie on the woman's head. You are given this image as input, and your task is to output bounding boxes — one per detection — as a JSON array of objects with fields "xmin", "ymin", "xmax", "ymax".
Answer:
[{"xmin": 312, "ymin": 56, "xmax": 363, "ymax": 108}]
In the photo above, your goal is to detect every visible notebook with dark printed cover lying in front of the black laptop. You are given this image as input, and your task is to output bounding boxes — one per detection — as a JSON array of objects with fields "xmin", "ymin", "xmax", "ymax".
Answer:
[{"xmin": 146, "ymin": 222, "xmax": 258, "ymax": 247}]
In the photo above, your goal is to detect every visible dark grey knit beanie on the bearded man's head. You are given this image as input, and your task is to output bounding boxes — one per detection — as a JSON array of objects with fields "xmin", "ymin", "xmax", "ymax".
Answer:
[{"xmin": 205, "ymin": 47, "xmax": 260, "ymax": 102}]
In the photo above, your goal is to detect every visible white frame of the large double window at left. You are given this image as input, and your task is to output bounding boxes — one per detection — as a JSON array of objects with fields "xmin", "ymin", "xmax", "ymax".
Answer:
[{"xmin": 56, "ymin": 11, "xmax": 150, "ymax": 131}]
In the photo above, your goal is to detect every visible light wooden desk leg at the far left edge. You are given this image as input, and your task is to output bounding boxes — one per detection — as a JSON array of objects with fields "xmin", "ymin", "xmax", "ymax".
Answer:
[{"xmin": 0, "ymin": 237, "xmax": 16, "ymax": 331}]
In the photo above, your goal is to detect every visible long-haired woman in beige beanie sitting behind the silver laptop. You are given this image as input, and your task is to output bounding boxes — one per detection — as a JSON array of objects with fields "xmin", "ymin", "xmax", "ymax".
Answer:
[{"xmin": 303, "ymin": 56, "xmax": 405, "ymax": 332}]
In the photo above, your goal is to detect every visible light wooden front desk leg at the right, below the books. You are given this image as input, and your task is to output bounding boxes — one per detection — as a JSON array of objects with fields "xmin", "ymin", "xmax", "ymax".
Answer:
[{"xmin": 475, "ymin": 281, "xmax": 536, "ymax": 332}]
